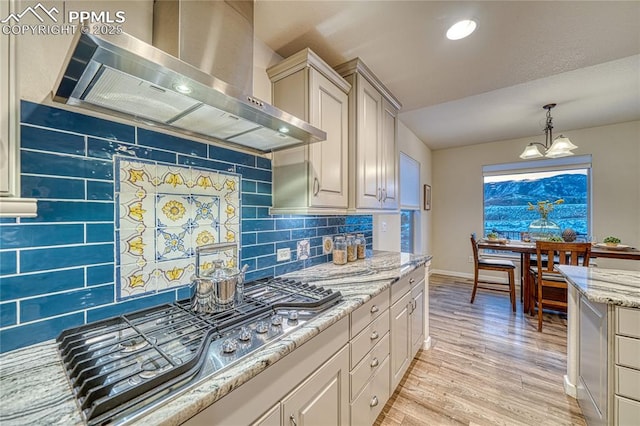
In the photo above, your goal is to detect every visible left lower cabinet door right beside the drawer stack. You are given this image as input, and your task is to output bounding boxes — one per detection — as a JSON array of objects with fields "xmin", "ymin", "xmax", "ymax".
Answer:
[{"xmin": 390, "ymin": 292, "xmax": 411, "ymax": 389}]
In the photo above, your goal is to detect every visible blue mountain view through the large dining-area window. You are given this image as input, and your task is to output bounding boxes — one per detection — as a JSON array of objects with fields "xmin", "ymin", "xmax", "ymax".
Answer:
[{"xmin": 484, "ymin": 169, "xmax": 589, "ymax": 238}]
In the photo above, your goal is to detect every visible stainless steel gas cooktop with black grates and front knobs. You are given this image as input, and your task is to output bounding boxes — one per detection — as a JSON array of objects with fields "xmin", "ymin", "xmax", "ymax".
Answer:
[{"xmin": 57, "ymin": 278, "xmax": 342, "ymax": 425}]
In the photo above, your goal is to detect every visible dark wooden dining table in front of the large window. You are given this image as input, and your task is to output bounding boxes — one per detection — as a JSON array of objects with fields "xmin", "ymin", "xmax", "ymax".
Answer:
[{"xmin": 478, "ymin": 239, "xmax": 640, "ymax": 312}]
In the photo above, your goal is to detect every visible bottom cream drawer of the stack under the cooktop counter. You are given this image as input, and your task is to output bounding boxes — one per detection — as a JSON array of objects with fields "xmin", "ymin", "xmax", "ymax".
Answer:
[{"xmin": 351, "ymin": 357, "xmax": 390, "ymax": 426}]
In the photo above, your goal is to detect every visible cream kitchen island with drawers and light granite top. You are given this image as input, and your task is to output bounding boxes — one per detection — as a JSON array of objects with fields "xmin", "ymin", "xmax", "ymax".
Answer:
[{"xmin": 557, "ymin": 265, "xmax": 640, "ymax": 425}]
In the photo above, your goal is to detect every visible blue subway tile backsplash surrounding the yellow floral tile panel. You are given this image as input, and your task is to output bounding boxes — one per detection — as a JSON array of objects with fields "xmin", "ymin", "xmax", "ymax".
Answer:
[{"xmin": 0, "ymin": 101, "xmax": 372, "ymax": 352}]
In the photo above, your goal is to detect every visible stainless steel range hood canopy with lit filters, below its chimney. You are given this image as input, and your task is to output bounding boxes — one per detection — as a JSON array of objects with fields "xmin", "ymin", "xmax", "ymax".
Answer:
[{"xmin": 53, "ymin": 2, "xmax": 326, "ymax": 153}]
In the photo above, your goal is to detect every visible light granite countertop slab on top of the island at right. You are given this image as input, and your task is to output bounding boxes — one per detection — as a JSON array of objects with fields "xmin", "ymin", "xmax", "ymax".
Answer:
[{"xmin": 556, "ymin": 265, "xmax": 640, "ymax": 308}]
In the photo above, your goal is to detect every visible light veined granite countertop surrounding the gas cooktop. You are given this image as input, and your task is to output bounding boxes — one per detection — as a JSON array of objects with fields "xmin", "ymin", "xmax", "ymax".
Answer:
[{"xmin": 0, "ymin": 251, "xmax": 431, "ymax": 426}]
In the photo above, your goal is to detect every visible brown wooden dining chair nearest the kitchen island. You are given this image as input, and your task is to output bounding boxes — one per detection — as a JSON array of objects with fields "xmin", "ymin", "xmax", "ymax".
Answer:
[{"xmin": 530, "ymin": 241, "xmax": 591, "ymax": 331}]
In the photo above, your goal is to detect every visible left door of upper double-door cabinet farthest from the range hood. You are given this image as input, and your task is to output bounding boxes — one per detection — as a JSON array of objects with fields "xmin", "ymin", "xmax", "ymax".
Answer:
[{"xmin": 356, "ymin": 75, "xmax": 382, "ymax": 209}]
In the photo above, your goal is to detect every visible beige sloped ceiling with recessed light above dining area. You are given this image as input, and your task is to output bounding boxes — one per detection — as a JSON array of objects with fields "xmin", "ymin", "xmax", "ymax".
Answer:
[{"xmin": 254, "ymin": 0, "xmax": 640, "ymax": 150}]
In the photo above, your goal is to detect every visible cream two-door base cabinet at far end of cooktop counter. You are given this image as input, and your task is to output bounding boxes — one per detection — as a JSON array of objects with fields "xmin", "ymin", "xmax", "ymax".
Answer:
[{"xmin": 390, "ymin": 267, "xmax": 425, "ymax": 389}]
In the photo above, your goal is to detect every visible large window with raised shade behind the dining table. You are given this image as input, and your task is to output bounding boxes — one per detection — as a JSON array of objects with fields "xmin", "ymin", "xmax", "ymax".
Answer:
[{"xmin": 483, "ymin": 155, "xmax": 591, "ymax": 239}]
